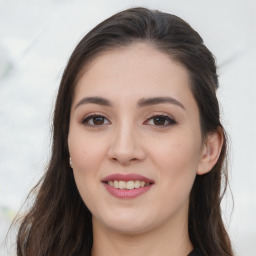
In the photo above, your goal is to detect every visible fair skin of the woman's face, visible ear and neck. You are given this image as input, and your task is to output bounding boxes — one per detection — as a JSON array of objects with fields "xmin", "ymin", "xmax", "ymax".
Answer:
[{"xmin": 68, "ymin": 43, "xmax": 222, "ymax": 256}]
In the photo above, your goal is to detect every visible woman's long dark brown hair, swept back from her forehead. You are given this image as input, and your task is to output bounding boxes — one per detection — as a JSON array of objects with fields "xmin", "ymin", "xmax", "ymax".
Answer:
[{"xmin": 17, "ymin": 8, "xmax": 233, "ymax": 256}]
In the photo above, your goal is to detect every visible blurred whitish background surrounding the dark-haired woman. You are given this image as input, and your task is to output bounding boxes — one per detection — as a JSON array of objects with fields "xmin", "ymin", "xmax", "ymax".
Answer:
[{"xmin": 0, "ymin": 0, "xmax": 256, "ymax": 256}]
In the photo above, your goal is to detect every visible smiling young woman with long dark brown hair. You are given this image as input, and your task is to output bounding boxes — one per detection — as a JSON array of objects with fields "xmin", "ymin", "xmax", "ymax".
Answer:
[{"xmin": 17, "ymin": 8, "xmax": 233, "ymax": 256}]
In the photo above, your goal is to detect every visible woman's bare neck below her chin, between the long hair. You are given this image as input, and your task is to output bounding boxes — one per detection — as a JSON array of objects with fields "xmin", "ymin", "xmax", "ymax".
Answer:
[{"xmin": 92, "ymin": 215, "xmax": 193, "ymax": 256}]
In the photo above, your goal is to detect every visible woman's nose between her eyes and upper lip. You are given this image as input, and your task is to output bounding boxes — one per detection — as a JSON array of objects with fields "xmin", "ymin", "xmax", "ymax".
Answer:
[{"xmin": 108, "ymin": 125, "xmax": 145, "ymax": 165}]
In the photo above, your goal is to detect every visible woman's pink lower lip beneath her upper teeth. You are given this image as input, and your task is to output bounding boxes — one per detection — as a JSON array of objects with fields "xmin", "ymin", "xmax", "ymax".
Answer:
[{"xmin": 103, "ymin": 183, "xmax": 153, "ymax": 199}]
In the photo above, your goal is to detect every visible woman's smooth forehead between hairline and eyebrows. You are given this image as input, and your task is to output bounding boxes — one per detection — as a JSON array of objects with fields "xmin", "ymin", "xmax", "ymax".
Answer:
[{"xmin": 74, "ymin": 43, "xmax": 193, "ymax": 108}]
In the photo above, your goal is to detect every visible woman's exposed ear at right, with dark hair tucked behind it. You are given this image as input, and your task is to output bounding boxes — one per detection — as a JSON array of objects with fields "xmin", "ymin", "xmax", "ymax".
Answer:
[{"xmin": 197, "ymin": 128, "xmax": 223, "ymax": 175}]
